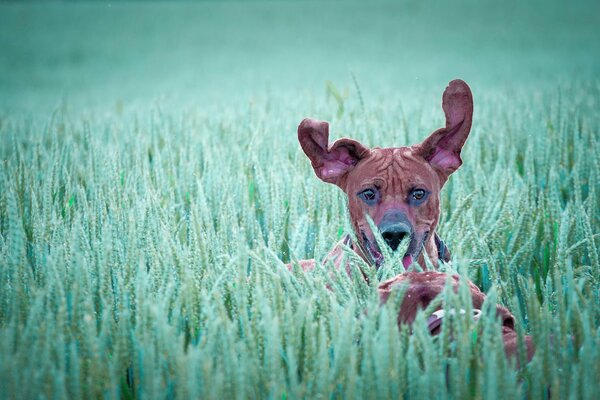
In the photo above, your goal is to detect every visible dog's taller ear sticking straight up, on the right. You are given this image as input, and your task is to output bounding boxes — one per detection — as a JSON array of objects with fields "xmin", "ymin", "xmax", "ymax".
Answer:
[{"xmin": 415, "ymin": 79, "xmax": 473, "ymax": 178}]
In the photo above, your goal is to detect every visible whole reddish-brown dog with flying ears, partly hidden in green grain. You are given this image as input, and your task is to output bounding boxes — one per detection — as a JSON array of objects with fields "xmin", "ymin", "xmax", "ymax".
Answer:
[{"xmin": 288, "ymin": 80, "xmax": 534, "ymax": 360}]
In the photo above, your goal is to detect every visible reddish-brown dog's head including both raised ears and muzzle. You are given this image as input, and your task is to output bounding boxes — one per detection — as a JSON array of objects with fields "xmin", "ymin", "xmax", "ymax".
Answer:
[{"xmin": 298, "ymin": 80, "xmax": 473, "ymax": 267}]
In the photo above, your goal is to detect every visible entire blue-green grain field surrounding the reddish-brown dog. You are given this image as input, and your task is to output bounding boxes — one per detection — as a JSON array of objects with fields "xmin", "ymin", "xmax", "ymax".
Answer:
[{"xmin": 0, "ymin": 0, "xmax": 600, "ymax": 399}]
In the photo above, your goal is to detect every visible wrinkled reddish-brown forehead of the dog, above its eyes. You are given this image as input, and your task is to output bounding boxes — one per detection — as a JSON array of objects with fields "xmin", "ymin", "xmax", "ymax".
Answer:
[{"xmin": 351, "ymin": 147, "xmax": 438, "ymax": 190}]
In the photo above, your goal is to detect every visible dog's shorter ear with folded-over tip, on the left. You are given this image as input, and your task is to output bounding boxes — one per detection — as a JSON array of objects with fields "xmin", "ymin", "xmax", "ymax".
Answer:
[{"xmin": 298, "ymin": 118, "xmax": 370, "ymax": 186}]
